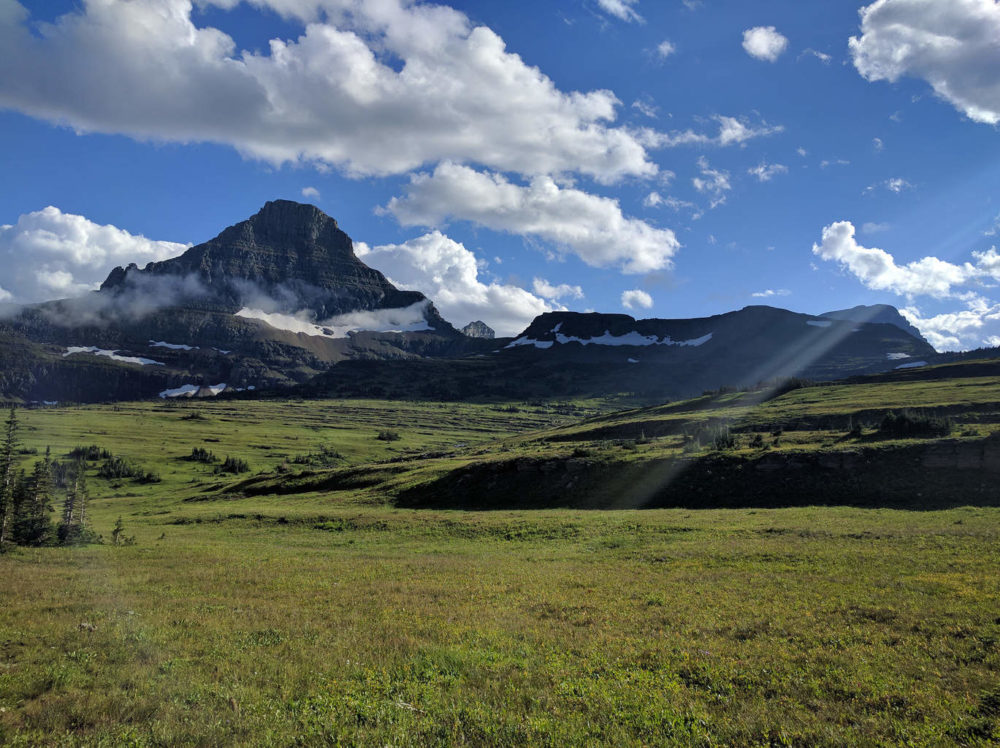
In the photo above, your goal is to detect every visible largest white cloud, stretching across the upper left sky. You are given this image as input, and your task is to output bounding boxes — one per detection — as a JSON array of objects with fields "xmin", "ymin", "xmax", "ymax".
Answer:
[{"xmin": 0, "ymin": 0, "xmax": 657, "ymax": 182}]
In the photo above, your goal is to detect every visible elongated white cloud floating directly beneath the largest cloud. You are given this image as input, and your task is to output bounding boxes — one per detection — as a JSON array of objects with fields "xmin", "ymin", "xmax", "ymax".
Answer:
[{"xmin": 385, "ymin": 162, "xmax": 680, "ymax": 273}]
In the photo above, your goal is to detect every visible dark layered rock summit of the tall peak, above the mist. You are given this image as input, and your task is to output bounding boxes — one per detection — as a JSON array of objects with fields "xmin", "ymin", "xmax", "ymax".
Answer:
[{"xmin": 101, "ymin": 200, "xmax": 450, "ymax": 329}]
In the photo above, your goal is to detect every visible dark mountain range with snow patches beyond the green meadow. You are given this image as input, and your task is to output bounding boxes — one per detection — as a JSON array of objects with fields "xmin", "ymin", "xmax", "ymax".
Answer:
[{"xmin": 0, "ymin": 200, "xmax": 968, "ymax": 402}]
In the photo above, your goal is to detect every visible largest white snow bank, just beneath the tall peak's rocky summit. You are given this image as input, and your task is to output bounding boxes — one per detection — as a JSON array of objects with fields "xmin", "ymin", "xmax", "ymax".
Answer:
[{"xmin": 240, "ymin": 301, "xmax": 433, "ymax": 342}]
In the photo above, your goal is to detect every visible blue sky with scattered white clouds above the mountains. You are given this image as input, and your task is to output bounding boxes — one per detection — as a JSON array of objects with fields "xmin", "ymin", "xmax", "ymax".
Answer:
[{"xmin": 0, "ymin": 0, "xmax": 1000, "ymax": 349}]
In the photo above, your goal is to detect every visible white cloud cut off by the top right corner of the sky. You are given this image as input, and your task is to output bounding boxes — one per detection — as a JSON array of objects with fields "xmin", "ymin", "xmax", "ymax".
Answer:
[{"xmin": 849, "ymin": 0, "xmax": 1000, "ymax": 125}]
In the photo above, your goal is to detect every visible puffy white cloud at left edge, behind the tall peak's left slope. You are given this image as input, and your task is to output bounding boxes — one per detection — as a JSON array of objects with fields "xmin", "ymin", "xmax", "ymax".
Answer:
[{"xmin": 0, "ymin": 205, "xmax": 190, "ymax": 304}]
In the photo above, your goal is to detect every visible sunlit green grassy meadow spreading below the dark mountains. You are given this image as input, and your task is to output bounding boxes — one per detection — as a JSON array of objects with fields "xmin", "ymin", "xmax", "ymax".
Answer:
[{"xmin": 0, "ymin": 372, "xmax": 1000, "ymax": 746}]
